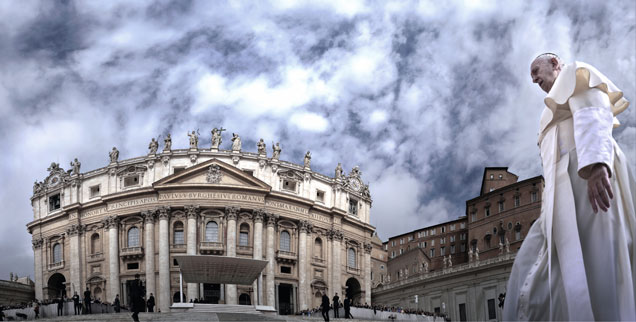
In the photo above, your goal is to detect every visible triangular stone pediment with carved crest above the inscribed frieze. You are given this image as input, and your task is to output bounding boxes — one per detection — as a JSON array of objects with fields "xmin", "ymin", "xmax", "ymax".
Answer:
[{"xmin": 153, "ymin": 159, "xmax": 271, "ymax": 191}]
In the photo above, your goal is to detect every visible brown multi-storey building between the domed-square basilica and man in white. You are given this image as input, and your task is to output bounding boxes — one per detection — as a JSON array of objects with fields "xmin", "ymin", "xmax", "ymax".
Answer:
[{"xmin": 372, "ymin": 168, "xmax": 543, "ymax": 321}]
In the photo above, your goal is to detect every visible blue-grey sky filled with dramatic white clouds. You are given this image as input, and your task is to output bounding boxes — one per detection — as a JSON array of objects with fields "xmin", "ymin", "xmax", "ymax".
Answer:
[{"xmin": 0, "ymin": 0, "xmax": 636, "ymax": 279}]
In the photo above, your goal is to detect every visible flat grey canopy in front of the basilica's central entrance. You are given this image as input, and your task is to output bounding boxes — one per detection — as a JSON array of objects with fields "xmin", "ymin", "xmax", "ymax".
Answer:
[{"xmin": 174, "ymin": 255, "xmax": 267, "ymax": 285}]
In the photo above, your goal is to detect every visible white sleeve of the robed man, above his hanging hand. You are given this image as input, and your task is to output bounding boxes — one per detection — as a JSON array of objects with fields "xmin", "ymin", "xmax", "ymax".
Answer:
[{"xmin": 568, "ymin": 88, "xmax": 614, "ymax": 179}]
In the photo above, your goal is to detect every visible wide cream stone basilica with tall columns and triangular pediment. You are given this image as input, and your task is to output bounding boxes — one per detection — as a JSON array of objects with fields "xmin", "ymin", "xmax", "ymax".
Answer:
[{"xmin": 27, "ymin": 135, "xmax": 381, "ymax": 314}]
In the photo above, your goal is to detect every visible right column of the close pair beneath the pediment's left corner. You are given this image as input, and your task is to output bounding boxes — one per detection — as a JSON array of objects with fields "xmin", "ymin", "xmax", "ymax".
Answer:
[{"xmin": 158, "ymin": 206, "xmax": 171, "ymax": 312}]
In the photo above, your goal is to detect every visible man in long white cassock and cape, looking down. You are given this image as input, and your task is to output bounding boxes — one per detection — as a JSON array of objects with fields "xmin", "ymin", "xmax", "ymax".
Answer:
[{"xmin": 503, "ymin": 54, "xmax": 636, "ymax": 321}]
